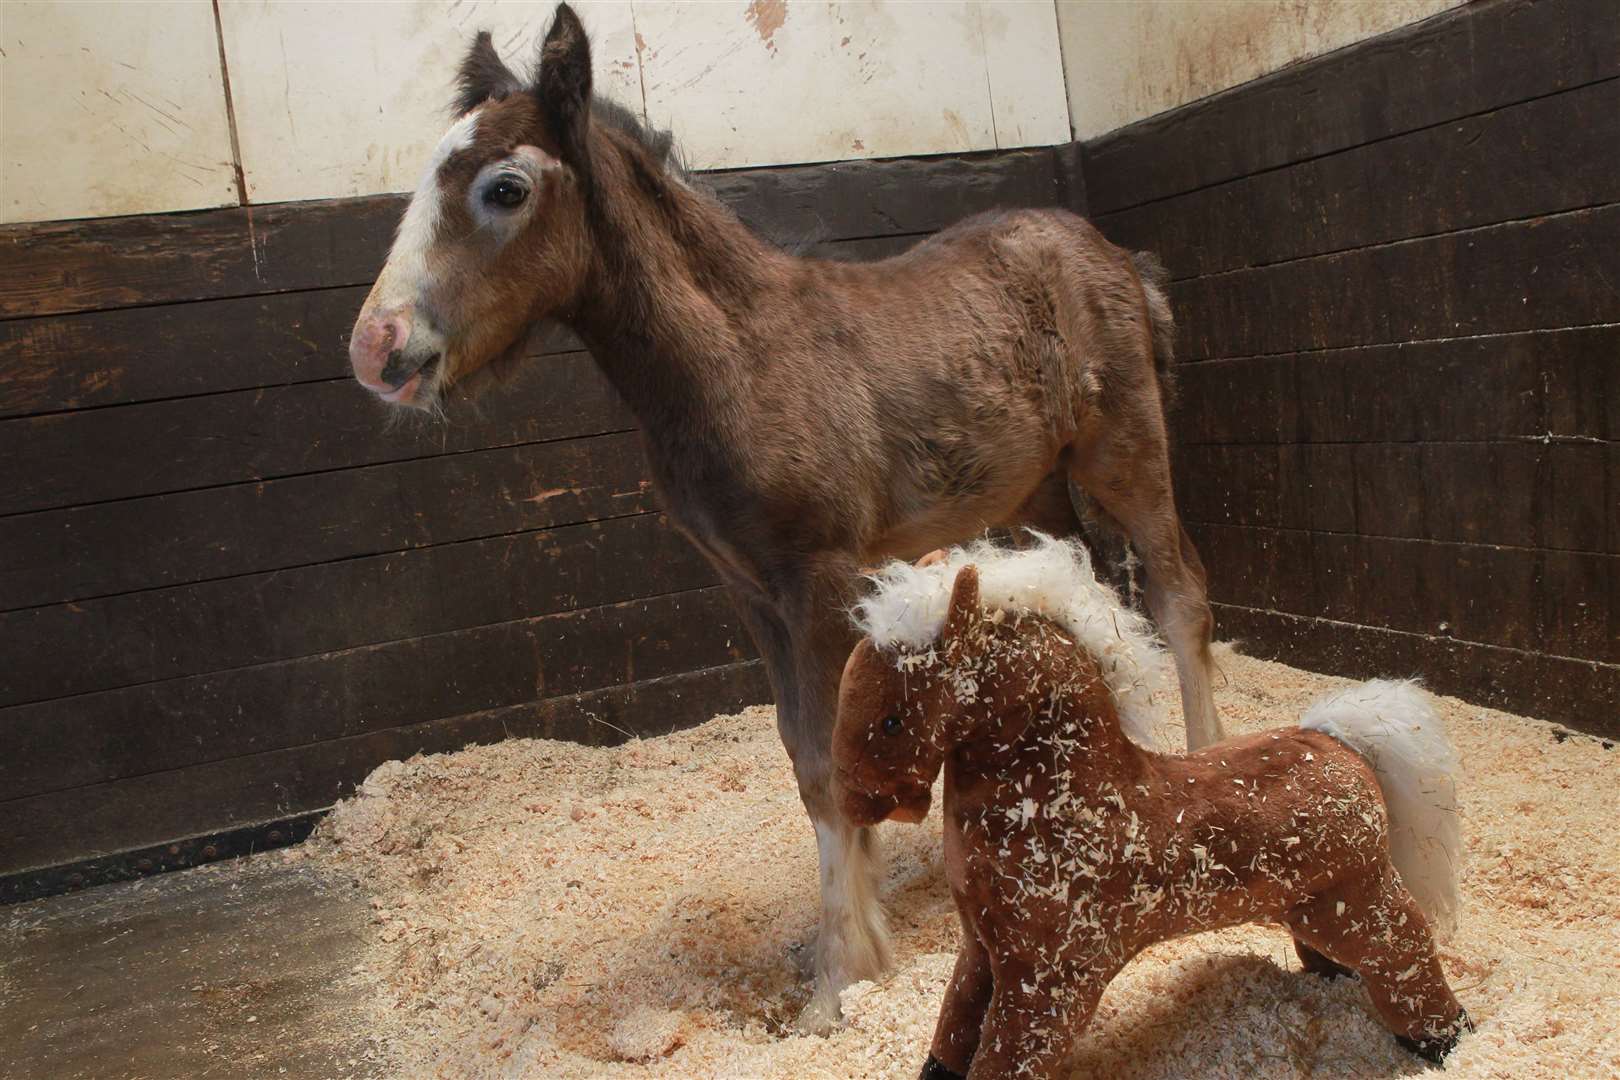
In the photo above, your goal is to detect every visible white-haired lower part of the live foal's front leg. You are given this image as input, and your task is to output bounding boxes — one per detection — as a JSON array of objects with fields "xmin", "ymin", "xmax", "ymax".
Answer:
[{"xmin": 799, "ymin": 819, "xmax": 889, "ymax": 1033}]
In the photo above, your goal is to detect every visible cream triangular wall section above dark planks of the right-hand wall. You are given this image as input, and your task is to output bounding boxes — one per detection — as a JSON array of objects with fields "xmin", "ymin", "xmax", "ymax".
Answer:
[{"xmin": 1058, "ymin": 0, "xmax": 1463, "ymax": 139}]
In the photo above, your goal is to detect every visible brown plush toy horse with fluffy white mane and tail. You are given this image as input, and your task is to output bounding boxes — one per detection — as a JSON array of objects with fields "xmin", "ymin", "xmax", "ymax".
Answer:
[{"xmin": 833, "ymin": 536, "xmax": 1471, "ymax": 1080}]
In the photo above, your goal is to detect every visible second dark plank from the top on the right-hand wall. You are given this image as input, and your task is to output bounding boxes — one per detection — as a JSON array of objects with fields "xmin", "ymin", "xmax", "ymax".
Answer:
[{"xmin": 1097, "ymin": 79, "xmax": 1620, "ymax": 279}]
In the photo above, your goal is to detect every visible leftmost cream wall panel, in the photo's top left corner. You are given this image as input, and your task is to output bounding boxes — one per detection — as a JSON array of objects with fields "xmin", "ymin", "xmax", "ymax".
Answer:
[{"xmin": 0, "ymin": 0, "xmax": 237, "ymax": 222}]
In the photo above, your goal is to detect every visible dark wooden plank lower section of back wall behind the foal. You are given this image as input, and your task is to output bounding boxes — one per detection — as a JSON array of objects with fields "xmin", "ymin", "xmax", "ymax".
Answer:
[{"xmin": 0, "ymin": 151, "xmax": 1076, "ymax": 902}]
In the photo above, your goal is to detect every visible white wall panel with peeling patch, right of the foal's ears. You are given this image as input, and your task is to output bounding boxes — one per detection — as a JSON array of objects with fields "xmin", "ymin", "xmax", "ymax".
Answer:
[{"xmin": 635, "ymin": 0, "xmax": 996, "ymax": 168}]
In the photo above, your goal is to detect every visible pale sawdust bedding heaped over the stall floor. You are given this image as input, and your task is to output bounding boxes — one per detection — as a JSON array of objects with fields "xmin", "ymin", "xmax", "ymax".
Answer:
[{"xmin": 305, "ymin": 653, "xmax": 1620, "ymax": 1080}]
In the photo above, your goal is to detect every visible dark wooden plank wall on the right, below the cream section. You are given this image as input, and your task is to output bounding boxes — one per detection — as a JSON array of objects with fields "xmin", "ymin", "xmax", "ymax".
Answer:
[{"xmin": 1084, "ymin": 0, "xmax": 1620, "ymax": 735}]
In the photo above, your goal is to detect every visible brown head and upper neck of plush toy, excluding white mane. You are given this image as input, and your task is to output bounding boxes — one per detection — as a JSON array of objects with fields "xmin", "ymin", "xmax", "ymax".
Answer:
[{"xmin": 833, "ymin": 567, "xmax": 1058, "ymax": 824}]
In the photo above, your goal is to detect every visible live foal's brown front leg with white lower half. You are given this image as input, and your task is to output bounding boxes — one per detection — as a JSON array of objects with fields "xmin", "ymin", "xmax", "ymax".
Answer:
[{"xmin": 744, "ymin": 560, "xmax": 889, "ymax": 1031}]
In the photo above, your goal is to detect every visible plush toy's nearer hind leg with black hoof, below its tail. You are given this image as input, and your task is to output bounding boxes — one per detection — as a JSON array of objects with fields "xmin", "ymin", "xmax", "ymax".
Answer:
[{"xmin": 1288, "ymin": 870, "xmax": 1473, "ymax": 1062}]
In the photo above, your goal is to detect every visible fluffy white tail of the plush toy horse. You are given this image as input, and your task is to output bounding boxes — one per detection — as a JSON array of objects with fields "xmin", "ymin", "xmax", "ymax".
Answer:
[{"xmin": 1299, "ymin": 678, "xmax": 1463, "ymax": 938}]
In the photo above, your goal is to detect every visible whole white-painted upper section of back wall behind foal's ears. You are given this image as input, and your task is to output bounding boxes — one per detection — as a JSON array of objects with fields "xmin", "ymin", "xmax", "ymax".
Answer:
[{"xmin": 0, "ymin": 0, "xmax": 1069, "ymax": 222}]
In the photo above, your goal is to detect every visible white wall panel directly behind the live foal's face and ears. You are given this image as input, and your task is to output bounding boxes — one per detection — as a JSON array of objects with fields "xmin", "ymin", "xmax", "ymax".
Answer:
[{"xmin": 220, "ymin": 0, "xmax": 642, "ymax": 202}]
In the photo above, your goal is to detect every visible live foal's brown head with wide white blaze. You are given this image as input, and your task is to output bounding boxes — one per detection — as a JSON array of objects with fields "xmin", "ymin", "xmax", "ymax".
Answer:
[{"xmin": 348, "ymin": 3, "xmax": 612, "ymax": 408}]
